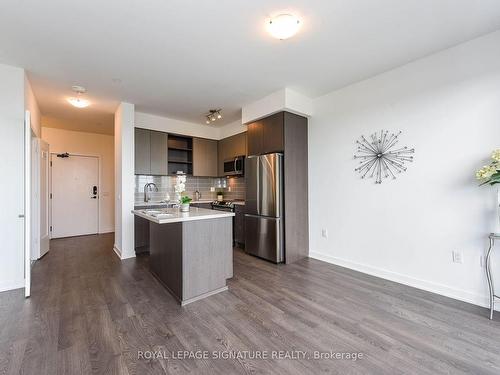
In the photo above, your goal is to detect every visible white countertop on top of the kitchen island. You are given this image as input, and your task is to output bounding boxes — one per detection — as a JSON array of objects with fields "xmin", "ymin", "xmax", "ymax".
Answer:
[{"xmin": 132, "ymin": 207, "xmax": 234, "ymax": 224}]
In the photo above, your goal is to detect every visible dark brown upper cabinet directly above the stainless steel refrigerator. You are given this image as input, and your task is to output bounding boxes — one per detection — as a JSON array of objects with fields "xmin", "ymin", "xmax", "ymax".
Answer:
[{"xmin": 247, "ymin": 112, "xmax": 285, "ymax": 155}]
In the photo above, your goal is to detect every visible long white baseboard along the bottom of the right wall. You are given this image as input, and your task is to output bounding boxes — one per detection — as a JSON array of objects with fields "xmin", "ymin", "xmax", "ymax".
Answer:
[{"xmin": 309, "ymin": 251, "xmax": 500, "ymax": 311}]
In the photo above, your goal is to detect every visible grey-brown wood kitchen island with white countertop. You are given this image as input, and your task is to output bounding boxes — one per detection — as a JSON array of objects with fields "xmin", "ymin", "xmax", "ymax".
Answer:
[{"xmin": 132, "ymin": 207, "xmax": 234, "ymax": 305}]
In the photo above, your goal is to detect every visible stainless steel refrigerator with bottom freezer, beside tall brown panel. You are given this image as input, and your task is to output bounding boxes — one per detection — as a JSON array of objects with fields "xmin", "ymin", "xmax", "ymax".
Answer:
[{"xmin": 245, "ymin": 153, "xmax": 285, "ymax": 263}]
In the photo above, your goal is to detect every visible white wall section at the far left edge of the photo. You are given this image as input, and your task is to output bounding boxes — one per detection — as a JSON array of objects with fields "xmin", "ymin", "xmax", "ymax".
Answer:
[{"xmin": 0, "ymin": 65, "xmax": 24, "ymax": 291}]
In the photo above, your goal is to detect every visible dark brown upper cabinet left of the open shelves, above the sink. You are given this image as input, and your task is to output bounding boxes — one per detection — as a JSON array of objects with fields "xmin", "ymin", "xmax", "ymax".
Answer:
[{"xmin": 135, "ymin": 128, "xmax": 168, "ymax": 176}]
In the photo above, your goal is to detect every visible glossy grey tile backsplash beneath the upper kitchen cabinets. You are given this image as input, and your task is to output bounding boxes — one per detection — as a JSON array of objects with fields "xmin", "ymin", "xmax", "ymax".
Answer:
[{"xmin": 135, "ymin": 175, "xmax": 245, "ymax": 203}]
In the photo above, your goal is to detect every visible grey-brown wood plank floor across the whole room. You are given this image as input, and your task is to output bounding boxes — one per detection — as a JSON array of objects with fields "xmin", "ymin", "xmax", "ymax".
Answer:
[{"xmin": 0, "ymin": 235, "xmax": 500, "ymax": 375}]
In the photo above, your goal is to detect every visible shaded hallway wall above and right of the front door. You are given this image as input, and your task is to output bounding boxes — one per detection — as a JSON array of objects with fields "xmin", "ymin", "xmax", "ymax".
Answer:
[{"xmin": 42, "ymin": 127, "xmax": 115, "ymax": 233}]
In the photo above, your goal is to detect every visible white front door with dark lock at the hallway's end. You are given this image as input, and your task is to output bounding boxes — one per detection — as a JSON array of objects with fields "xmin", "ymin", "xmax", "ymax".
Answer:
[{"xmin": 51, "ymin": 154, "xmax": 99, "ymax": 238}]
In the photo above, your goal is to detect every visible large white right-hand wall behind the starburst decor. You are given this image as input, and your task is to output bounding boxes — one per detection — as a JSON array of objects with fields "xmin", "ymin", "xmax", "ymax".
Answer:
[{"xmin": 309, "ymin": 32, "xmax": 500, "ymax": 312}]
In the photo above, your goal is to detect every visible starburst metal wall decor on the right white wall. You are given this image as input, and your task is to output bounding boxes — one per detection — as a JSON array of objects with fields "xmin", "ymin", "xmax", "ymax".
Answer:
[{"xmin": 354, "ymin": 130, "xmax": 415, "ymax": 184}]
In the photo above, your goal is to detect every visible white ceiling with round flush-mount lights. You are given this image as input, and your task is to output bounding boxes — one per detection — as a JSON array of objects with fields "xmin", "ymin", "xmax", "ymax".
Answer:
[{"xmin": 0, "ymin": 0, "xmax": 500, "ymax": 134}]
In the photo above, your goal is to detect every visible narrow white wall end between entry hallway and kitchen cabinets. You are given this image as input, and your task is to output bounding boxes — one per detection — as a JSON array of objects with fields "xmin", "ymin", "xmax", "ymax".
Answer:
[{"xmin": 114, "ymin": 103, "xmax": 135, "ymax": 259}]
